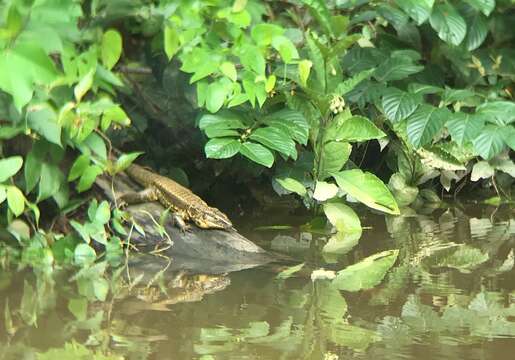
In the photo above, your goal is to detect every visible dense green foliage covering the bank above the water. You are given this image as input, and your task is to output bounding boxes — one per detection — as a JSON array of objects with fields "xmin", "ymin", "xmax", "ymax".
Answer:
[{"xmin": 0, "ymin": 0, "xmax": 515, "ymax": 272}]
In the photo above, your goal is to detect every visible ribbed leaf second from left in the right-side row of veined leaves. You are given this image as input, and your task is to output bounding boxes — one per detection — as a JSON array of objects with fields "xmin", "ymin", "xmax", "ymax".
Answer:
[{"xmin": 407, "ymin": 104, "xmax": 451, "ymax": 148}]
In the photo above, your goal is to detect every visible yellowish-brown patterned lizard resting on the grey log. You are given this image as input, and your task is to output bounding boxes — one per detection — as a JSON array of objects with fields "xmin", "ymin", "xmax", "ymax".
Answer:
[{"xmin": 119, "ymin": 164, "xmax": 233, "ymax": 232}]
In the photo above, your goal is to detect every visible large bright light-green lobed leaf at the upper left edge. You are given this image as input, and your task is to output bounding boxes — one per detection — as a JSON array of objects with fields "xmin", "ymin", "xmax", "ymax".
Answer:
[{"xmin": 0, "ymin": 41, "xmax": 57, "ymax": 111}]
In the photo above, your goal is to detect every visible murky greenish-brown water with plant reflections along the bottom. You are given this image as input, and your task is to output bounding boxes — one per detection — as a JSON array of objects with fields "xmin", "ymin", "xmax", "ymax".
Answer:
[{"xmin": 0, "ymin": 205, "xmax": 515, "ymax": 359}]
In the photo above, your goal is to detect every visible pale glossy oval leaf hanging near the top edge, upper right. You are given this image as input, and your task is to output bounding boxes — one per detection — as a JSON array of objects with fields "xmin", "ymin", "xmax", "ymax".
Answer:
[{"xmin": 429, "ymin": 2, "xmax": 467, "ymax": 46}]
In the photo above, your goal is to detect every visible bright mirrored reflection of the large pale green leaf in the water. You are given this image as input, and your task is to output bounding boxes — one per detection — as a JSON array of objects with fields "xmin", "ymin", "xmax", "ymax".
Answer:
[{"xmin": 333, "ymin": 250, "xmax": 399, "ymax": 291}]
